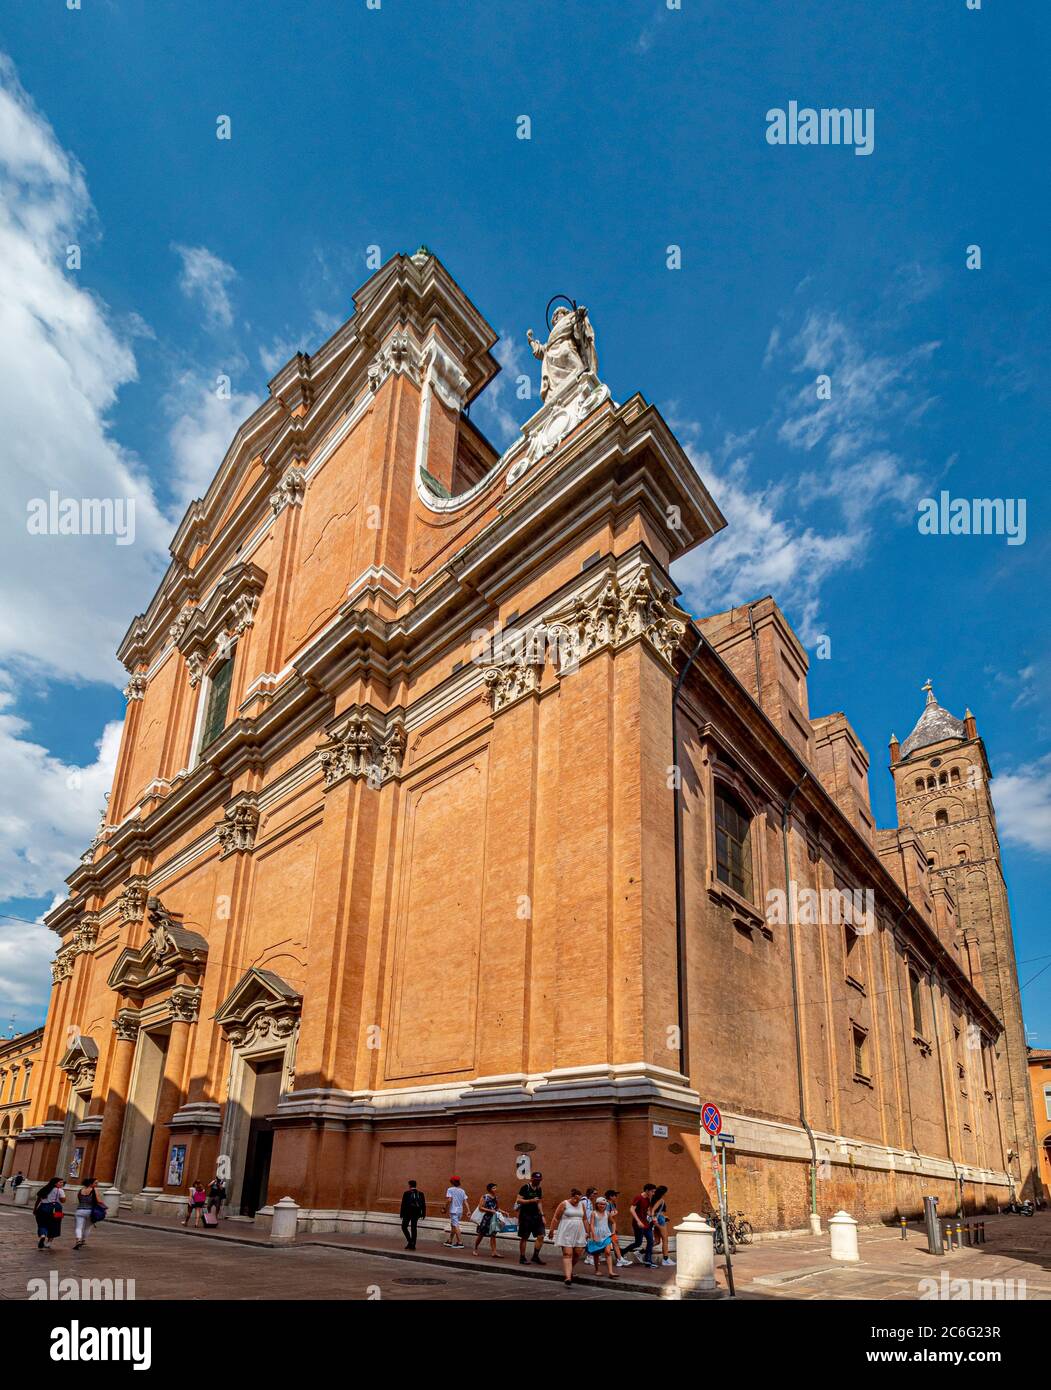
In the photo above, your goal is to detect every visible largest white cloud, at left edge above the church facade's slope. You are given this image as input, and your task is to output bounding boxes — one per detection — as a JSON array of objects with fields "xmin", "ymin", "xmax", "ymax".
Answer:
[{"xmin": 0, "ymin": 56, "xmax": 170, "ymax": 681}]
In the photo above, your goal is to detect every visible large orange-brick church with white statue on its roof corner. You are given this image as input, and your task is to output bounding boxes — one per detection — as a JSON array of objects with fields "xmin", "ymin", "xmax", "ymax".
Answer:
[{"xmin": 12, "ymin": 247, "xmax": 1032, "ymax": 1229}]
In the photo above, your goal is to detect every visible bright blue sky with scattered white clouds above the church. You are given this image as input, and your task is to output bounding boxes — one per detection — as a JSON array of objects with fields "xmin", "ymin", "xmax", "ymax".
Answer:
[{"xmin": 0, "ymin": 0, "xmax": 1051, "ymax": 1047}]
